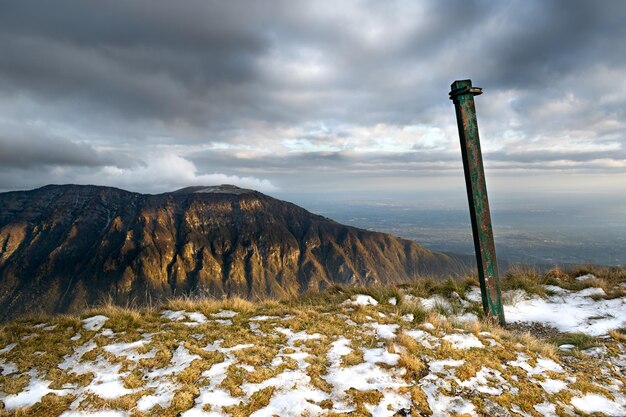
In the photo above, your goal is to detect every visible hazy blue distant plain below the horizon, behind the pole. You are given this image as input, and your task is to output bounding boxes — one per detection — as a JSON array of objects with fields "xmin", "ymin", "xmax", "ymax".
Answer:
[{"xmin": 294, "ymin": 200, "xmax": 626, "ymax": 266}]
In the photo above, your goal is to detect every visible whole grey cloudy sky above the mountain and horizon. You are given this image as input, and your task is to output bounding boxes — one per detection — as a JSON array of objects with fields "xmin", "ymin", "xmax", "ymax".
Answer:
[{"xmin": 0, "ymin": 0, "xmax": 626, "ymax": 205}]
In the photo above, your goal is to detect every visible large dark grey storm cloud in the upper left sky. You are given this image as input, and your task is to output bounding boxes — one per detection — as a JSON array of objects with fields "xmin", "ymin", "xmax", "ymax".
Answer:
[{"xmin": 0, "ymin": 1, "xmax": 265, "ymax": 120}]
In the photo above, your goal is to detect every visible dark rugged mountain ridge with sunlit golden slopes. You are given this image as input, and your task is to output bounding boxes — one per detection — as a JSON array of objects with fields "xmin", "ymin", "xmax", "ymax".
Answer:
[{"xmin": 0, "ymin": 185, "xmax": 463, "ymax": 319}]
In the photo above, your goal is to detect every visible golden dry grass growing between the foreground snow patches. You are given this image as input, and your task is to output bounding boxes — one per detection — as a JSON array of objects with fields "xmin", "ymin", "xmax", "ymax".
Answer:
[{"xmin": 0, "ymin": 267, "xmax": 626, "ymax": 417}]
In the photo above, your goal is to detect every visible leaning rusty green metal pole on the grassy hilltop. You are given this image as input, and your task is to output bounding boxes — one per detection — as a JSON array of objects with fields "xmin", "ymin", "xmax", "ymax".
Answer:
[{"xmin": 450, "ymin": 80, "xmax": 505, "ymax": 325}]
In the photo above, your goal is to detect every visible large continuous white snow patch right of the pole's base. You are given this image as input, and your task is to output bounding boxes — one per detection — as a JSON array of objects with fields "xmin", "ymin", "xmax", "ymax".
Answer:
[{"xmin": 504, "ymin": 287, "xmax": 626, "ymax": 336}]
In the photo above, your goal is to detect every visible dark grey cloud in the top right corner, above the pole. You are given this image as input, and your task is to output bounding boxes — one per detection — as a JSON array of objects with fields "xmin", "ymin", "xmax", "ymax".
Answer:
[{"xmin": 487, "ymin": 0, "xmax": 626, "ymax": 89}]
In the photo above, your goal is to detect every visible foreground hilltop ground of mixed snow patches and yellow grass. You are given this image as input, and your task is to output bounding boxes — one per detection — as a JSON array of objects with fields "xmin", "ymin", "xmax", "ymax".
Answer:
[{"xmin": 0, "ymin": 274, "xmax": 626, "ymax": 417}]
